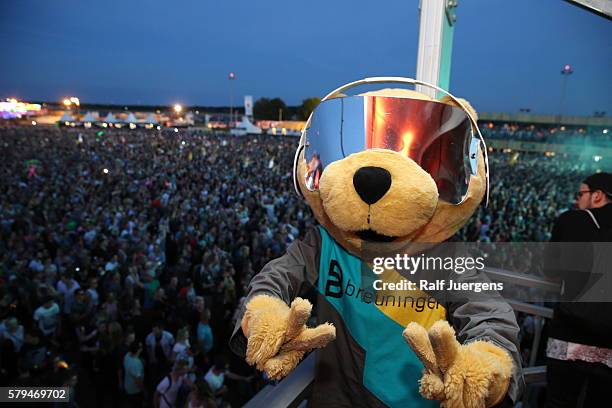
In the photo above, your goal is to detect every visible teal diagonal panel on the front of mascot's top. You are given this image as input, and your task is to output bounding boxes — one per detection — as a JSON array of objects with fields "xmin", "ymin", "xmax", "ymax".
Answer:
[{"xmin": 317, "ymin": 227, "xmax": 438, "ymax": 408}]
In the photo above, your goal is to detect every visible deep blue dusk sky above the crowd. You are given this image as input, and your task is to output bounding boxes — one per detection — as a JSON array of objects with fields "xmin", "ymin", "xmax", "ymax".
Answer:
[{"xmin": 0, "ymin": 0, "xmax": 612, "ymax": 116}]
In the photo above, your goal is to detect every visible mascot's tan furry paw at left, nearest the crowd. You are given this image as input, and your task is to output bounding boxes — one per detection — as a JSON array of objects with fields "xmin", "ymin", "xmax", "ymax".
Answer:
[{"xmin": 241, "ymin": 295, "xmax": 336, "ymax": 380}]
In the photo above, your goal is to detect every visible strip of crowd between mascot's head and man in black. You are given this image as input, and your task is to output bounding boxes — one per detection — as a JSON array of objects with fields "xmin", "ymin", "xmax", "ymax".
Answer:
[{"xmin": 455, "ymin": 152, "xmax": 605, "ymax": 242}]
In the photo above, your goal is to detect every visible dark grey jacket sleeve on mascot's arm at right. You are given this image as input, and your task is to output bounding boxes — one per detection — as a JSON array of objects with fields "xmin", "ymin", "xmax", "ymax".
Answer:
[{"xmin": 447, "ymin": 270, "xmax": 525, "ymax": 403}]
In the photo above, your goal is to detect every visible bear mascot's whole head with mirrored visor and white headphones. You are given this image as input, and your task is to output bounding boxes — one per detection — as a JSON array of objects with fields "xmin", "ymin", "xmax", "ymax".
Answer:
[{"xmin": 294, "ymin": 77, "xmax": 488, "ymax": 258}]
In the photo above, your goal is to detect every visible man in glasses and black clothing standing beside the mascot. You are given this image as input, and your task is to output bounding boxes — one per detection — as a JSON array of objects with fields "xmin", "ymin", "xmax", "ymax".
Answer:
[{"xmin": 546, "ymin": 173, "xmax": 612, "ymax": 407}]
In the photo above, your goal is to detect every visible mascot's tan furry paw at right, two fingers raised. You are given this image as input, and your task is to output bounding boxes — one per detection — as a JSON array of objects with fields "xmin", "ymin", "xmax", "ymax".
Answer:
[{"xmin": 403, "ymin": 320, "xmax": 512, "ymax": 408}]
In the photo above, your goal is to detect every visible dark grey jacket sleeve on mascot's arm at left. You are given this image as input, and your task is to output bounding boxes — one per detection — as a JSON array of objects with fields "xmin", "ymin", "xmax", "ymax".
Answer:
[{"xmin": 230, "ymin": 228, "xmax": 321, "ymax": 357}]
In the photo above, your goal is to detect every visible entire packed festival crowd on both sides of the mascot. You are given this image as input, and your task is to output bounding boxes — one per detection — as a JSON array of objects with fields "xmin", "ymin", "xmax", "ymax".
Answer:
[{"xmin": 0, "ymin": 126, "xmax": 608, "ymax": 407}]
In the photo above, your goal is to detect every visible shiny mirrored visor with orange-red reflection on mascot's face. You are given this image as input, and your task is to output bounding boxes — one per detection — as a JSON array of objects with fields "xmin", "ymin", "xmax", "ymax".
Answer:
[{"xmin": 304, "ymin": 96, "xmax": 478, "ymax": 204}]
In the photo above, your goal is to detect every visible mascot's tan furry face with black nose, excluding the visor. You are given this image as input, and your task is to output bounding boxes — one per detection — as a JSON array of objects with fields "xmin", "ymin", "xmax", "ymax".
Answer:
[{"xmin": 297, "ymin": 89, "xmax": 486, "ymax": 258}]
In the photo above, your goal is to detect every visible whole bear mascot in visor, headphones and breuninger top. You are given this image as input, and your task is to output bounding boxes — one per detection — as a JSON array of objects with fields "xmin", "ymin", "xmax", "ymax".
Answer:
[{"xmin": 230, "ymin": 77, "xmax": 523, "ymax": 408}]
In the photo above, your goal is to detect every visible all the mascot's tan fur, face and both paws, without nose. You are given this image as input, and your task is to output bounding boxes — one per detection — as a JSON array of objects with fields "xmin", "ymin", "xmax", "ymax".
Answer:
[{"xmin": 242, "ymin": 89, "xmax": 512, "ymax": 408}]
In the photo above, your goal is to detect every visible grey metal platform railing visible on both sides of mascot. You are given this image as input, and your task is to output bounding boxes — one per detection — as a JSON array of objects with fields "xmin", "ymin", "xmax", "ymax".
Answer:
[{"xmin": 244, "ymin": 268, "xmax": 561, "ymax": 408}]
